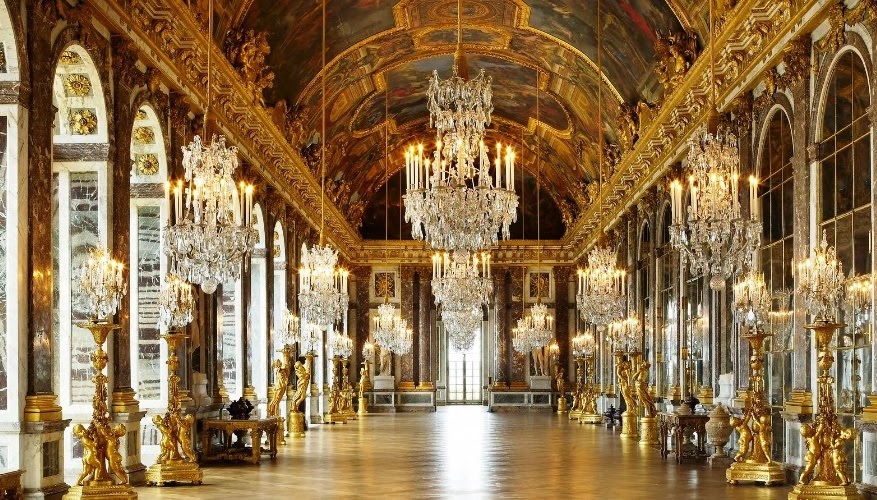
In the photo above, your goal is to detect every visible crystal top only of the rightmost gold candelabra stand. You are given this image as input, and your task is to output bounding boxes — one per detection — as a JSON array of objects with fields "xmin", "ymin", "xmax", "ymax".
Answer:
[{"xmin": 795, "ymin": 231, "xmax": 844, "ymax": 322}]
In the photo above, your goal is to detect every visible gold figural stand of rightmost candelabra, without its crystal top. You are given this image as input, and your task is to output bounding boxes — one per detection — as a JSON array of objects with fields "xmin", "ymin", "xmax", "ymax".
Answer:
[{"xmin": 789, "ymin": 321, "xmax": 862, "ymax": 500}]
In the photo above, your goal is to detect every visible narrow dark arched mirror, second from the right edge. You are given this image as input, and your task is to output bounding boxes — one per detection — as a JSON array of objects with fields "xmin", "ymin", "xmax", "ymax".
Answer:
[{"xmin": 758, "ymin": 109, "xmax": 794, "ymax": 460}]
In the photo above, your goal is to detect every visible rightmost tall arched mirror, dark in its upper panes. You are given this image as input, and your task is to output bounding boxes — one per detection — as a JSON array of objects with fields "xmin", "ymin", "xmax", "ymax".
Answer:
[{"xmin": 813, "ymin": 49, "xmax": 872, "ymax": 481}]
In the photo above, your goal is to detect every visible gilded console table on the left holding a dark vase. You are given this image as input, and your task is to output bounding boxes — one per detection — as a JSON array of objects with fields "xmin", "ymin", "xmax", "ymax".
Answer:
[{"xmin": 201, "ymin": 417, "xmax": 280, "ymax": 465}]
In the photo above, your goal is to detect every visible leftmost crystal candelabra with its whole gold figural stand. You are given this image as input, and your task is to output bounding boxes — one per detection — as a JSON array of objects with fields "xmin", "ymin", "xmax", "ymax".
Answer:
[{"xmin": 64, "ymin": 248, "xmax": 137, "ymax": 500}]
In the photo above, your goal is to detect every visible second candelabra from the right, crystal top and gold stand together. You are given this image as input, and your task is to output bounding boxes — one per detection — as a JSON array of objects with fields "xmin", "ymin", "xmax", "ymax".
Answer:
[{"xmin": 725, "ymin": 271, "xmax": 786, "ymax": 485}]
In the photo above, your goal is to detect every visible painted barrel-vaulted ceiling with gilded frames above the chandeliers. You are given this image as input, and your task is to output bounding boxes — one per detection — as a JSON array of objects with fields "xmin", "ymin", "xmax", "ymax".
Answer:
[{"xmin": 215, "ymin": 0, "xmax": 706, "ymax": 237}]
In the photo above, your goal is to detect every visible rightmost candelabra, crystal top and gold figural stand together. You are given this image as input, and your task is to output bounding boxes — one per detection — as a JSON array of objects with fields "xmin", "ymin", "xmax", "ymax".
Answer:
[{"xmin": 789, "ymin": 232, "xmax": 862, "ymax": 499}]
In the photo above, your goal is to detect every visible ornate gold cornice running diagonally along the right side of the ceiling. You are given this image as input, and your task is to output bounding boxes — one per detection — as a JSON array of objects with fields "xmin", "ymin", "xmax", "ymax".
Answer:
[{"xmin": 564, "ymin": 0, "xmax": 828, "ymax": 259}]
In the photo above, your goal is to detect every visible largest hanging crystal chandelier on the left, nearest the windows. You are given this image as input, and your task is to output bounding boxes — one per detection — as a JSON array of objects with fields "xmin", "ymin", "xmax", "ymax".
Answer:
[{"xmin": 164, "ymin": 135, "xmax": 258, "ymax": 293}]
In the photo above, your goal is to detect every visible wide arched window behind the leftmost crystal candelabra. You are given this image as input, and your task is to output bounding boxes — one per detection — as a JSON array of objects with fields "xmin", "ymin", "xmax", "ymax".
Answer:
[{"xmin": 52, "ymin": 45, "xmax": 110, "ymax": 414}]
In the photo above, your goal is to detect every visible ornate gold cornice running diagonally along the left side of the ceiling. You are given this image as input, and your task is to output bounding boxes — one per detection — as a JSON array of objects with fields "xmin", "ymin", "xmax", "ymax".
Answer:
[{"xmin": 93, "ymin": 0, "xmax": 360, "ymax": 258}]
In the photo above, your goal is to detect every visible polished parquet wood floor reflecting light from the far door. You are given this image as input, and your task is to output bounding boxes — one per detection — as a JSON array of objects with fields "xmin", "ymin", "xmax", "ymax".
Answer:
[{"xmin": 137, "ymin": 406, "xmax": 791, "ymax": 500}]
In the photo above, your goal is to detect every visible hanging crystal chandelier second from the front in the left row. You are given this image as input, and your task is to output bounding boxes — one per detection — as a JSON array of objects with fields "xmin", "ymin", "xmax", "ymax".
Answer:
[{"xmin": 298, "ymin": 243, "xmax": 350, "ymax": 327}]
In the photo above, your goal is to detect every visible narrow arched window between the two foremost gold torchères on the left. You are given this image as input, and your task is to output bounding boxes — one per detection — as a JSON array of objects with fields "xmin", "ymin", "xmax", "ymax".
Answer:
[{"xmin": 129, "ymin": 105, "xmax": 168, "ymax": 408}]
